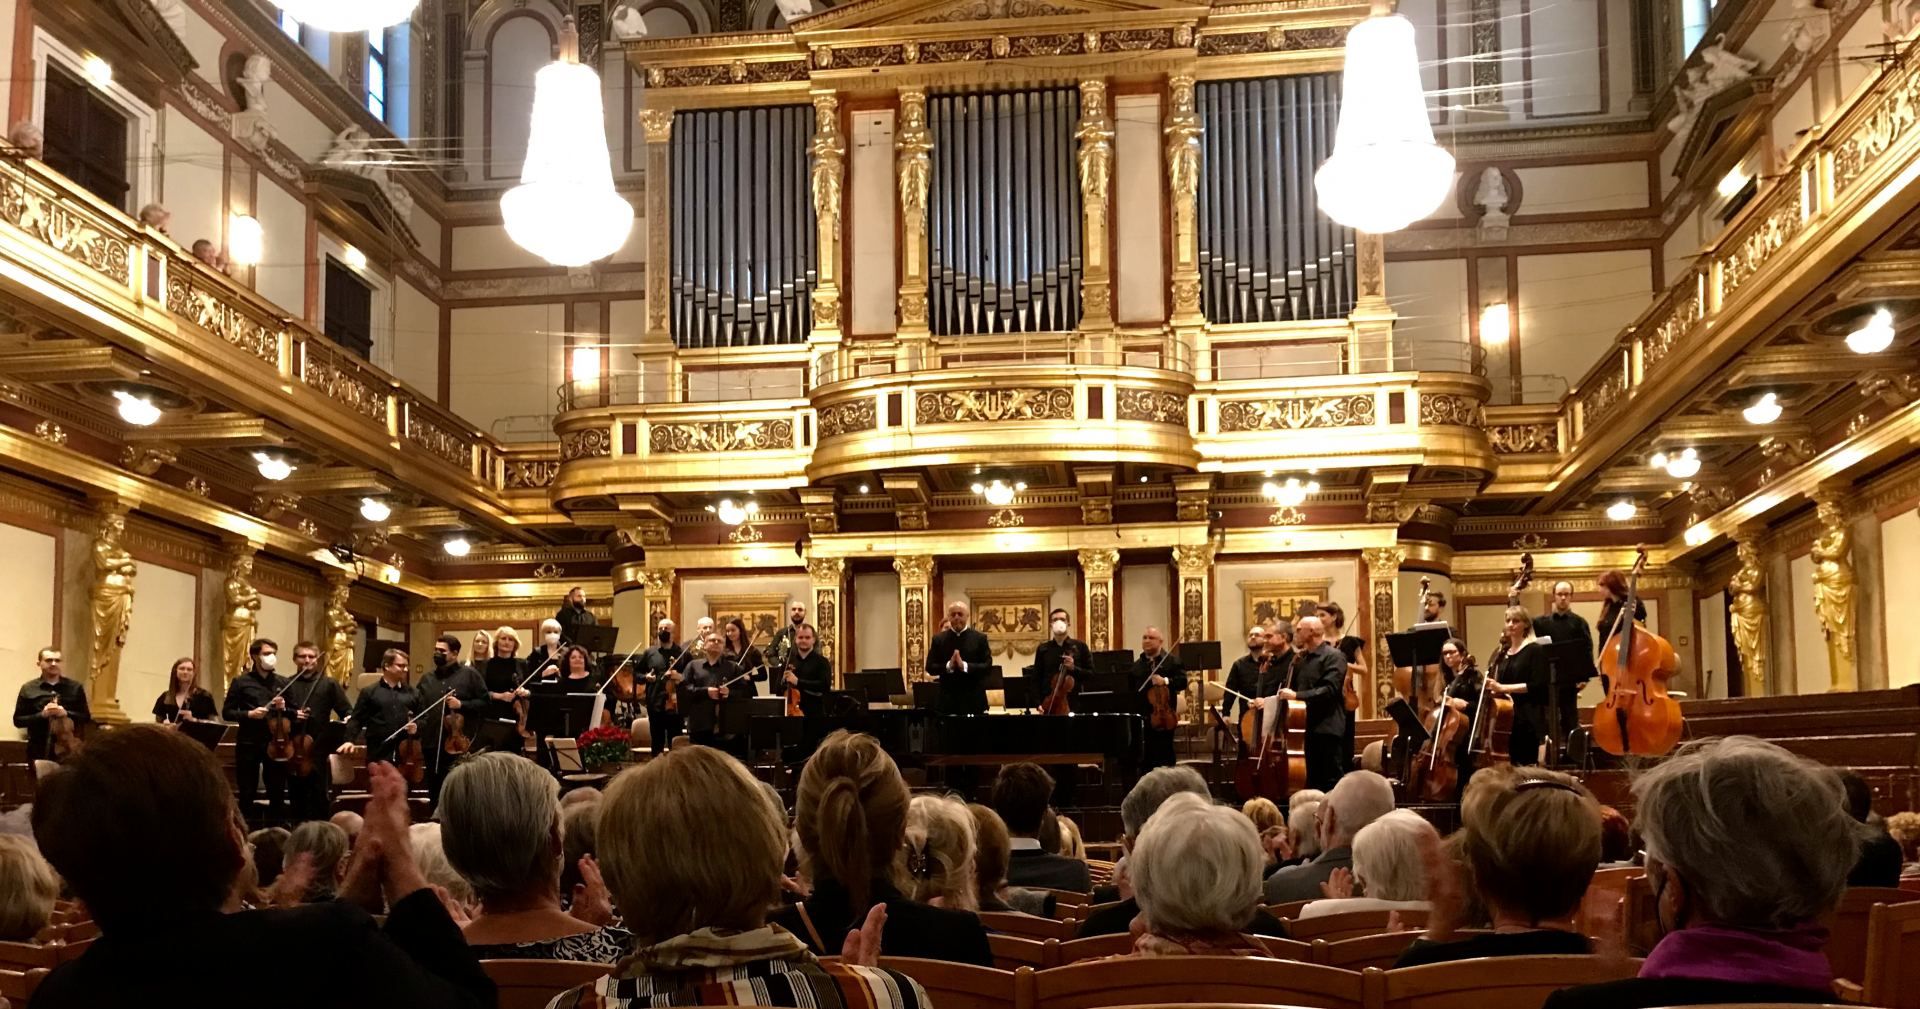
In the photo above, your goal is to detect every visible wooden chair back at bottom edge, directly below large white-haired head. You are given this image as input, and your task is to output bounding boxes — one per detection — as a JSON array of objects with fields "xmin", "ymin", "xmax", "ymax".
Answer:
[{"xmin": 1036, "ymin": 957, "xmax": 1367, "ymax": 1009}]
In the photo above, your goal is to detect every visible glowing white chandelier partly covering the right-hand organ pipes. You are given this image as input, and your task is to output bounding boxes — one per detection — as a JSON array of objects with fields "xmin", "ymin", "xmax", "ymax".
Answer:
[{"xmin": 1313, "ymin": 13, "xmax": 1453, "ymax": 234}]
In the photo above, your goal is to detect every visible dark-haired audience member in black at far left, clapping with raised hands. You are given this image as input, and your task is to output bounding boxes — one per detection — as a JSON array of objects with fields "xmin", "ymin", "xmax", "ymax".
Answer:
[{"xmin": 33, "ymin": 725, "xmax": 495, "ymax": 1009}]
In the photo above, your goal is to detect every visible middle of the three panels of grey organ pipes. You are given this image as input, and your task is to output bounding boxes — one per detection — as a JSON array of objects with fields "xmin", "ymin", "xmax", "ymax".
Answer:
[{"xmin": 927, "ymin": 88, "xmax": 1083, "ymax": 336}]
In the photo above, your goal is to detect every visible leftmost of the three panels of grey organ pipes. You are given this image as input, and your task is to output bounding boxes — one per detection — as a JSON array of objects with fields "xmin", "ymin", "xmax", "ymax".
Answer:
[{"xmin": 670, "ymin": 106, "xmax": 818, "ymax": 347}]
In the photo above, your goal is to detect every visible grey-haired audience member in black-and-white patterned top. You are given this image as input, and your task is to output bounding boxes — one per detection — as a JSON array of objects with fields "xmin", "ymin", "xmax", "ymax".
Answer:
[{"xmin": 438, "ymin": 752, "xmax": 632, "ymax": 963}]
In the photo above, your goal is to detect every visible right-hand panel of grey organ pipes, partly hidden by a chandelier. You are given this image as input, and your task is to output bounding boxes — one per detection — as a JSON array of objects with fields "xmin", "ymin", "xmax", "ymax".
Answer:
[{"xmin": 1196, "ymin": 73, "xmax": 1357, "ymax": 322}]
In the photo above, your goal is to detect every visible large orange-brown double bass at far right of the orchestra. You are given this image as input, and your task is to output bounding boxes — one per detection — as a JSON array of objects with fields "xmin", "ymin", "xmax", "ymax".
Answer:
[{"xmin": 1594, "ymin": 549, "xmax": 1686, "ymax": 756}]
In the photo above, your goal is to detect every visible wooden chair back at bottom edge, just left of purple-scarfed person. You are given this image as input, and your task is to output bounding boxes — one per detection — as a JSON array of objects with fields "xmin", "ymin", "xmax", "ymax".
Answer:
[{"xmin": 1365, "ymin": 955, "xmax": 1640, "ymax": 1009}]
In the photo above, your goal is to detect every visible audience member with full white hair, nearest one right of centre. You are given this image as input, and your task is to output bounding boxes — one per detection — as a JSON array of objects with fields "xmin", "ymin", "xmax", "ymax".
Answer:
[{"xmin": 1127, "ymin": 792, "xmax": 1267, "ymax": 957}]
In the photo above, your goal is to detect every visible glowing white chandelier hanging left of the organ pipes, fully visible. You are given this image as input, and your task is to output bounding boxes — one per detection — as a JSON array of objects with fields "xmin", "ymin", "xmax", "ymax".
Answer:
[{"xmin": 499, "ymin": 17, "xmax": 634, "ymax": 267}]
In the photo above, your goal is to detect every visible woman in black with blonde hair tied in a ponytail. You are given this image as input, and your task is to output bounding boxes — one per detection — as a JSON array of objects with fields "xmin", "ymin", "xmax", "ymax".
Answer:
[{"xmin": 771, "ymin": 731, "xmax": 993, "ymax": 967}]
